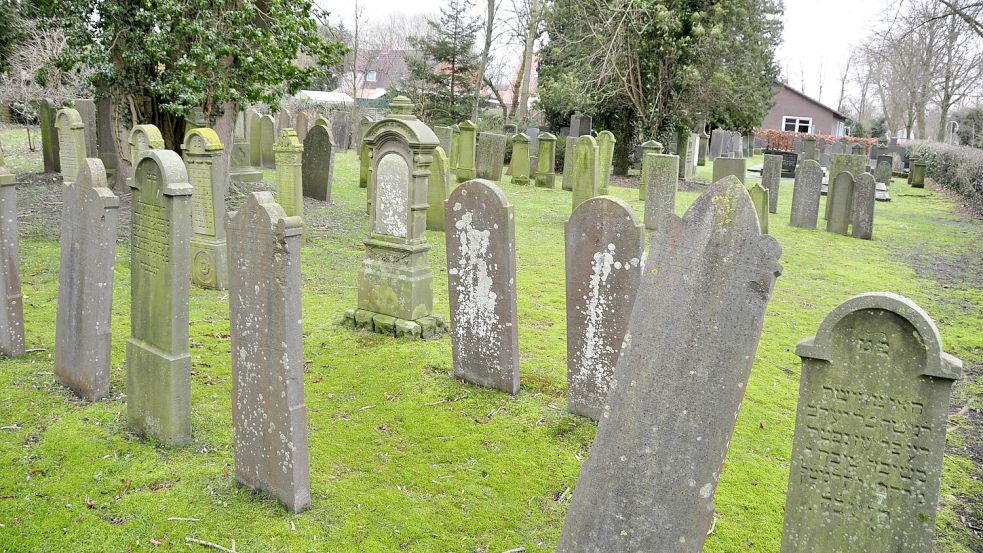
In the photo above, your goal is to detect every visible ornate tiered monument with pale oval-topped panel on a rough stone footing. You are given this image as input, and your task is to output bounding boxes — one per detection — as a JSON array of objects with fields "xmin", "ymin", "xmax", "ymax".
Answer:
[{"xmin": 345, "ymin": 96, "xmax": 442, "ymax": 338}]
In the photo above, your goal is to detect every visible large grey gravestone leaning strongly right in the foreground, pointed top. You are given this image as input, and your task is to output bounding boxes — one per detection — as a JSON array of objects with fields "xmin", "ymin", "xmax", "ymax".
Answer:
[{"xmin": 557, "ymin": 176, "xmax": 781, "ymax": 553}]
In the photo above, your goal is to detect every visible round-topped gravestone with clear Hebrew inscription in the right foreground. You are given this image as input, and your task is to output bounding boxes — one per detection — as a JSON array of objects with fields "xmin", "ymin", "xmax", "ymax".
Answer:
[{"xmin": 781, "ymin": 293, "xmax": 962, "ymax": 553}]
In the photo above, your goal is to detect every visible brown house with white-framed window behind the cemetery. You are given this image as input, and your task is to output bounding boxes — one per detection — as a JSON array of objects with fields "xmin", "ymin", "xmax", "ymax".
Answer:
[{"xmin": 760, "ymin": 84, "xmax": 846, "ymax": 136}]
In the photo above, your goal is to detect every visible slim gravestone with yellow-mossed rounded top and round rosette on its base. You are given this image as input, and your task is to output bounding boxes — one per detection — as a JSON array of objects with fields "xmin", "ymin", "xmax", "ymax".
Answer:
[{"xmin": 181, "ymin": 128, "xmax": 229, "ymax": 290}]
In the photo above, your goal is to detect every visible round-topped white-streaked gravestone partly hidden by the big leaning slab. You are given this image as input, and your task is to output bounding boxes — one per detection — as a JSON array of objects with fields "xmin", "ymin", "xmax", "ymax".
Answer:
[{"xmin": 565, "ymin": 196, "xmax": 645, "ymax": 420}]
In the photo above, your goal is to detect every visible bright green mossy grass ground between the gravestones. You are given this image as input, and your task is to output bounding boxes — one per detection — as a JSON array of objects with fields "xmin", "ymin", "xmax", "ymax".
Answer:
[{"xmin": 0, "ymin": 128, "xmax": 983, "ymax": 553}]
